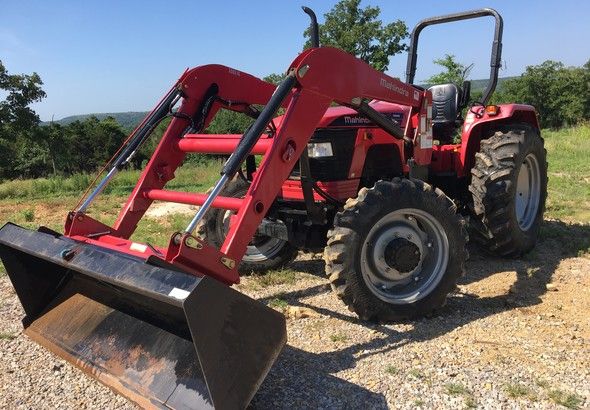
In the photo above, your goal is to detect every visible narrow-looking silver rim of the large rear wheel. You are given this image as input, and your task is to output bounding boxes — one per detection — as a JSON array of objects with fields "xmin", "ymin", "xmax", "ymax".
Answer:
[{"xmin": 514, "ymin": 153, "xmax": 541, "ymax": 231}]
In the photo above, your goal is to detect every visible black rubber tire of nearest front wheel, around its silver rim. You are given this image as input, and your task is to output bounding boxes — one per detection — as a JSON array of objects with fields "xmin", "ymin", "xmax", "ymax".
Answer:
[{"xmin": 335, "ymin": 179, "xmax": 466, "ymax": 321}]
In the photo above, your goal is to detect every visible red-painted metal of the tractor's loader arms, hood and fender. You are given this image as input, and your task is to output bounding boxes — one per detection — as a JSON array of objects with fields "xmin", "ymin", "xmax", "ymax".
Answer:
[{"xmin": 66, "ymin": 47, "xmax": 538, "ymax": 284}]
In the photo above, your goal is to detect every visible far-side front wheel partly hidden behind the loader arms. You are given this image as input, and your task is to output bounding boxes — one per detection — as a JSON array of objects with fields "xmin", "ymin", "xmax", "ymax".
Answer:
[{"xmin": 197, "ymin": 179, "xmax": 298, "ymax": 274}]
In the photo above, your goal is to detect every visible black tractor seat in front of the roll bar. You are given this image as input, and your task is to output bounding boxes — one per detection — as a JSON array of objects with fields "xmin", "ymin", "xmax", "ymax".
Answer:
[{"xmin": 429, "ymin": 84, "xmax": 461, "ymax": 141}]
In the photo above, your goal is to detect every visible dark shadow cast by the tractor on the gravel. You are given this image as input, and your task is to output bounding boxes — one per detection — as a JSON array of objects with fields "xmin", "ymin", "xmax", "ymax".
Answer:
[{"xmin": 253, "ymin": 221, "xmax": 590, "ymax": 408}]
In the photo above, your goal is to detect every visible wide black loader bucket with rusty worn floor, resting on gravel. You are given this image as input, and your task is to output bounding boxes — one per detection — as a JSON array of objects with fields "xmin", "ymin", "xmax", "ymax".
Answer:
[{"xmin": 0, "ymin": 223, "xmax": 286, "ymax": 409}]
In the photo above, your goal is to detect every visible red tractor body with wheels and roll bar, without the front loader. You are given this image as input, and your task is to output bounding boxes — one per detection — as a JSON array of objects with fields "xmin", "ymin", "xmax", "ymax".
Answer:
[{"xmin": 198, "ymin": 9, "xmax": 547, "ymax": 320}]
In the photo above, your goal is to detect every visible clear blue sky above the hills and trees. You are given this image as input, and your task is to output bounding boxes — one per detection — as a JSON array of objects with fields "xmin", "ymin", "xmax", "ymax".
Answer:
[{"xmin": 0, "ymin": 0, "xmax": 590, "ymax": 120}]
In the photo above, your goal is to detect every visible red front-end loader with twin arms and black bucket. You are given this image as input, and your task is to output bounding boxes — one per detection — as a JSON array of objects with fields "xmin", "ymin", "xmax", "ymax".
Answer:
[{"xmin": 0, "ymin": 11, "xmax": 430, "ymax": 408}]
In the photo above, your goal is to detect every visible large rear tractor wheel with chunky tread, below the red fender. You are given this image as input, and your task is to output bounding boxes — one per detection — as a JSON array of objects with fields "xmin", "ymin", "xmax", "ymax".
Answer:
[{"xmin": 469, "ymin": 124, "xmax": 547, "ymax": 256}]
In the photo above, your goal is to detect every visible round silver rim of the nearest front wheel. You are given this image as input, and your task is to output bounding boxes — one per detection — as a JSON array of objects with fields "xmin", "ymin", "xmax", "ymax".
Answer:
[{"xmin": 360, "ymin": 208, "xmax": 449, "ymax": 305}]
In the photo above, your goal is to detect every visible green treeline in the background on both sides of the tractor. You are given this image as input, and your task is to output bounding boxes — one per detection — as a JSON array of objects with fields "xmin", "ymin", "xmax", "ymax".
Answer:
[{"xmin": 0, "ymin": 57, "xmax": 590, "ymax": 180}]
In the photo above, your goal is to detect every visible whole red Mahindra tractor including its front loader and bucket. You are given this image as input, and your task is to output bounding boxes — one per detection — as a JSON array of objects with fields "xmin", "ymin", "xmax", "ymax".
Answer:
[{"xmin": 0, "ymin": 8, "xmax": 547, "ymax": 409}]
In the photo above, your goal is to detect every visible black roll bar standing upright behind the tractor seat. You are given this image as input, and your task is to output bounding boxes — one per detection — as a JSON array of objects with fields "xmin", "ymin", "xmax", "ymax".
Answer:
[{"xmin": 406, "ymin": 8, "xmax": 504, "ymax": 105}]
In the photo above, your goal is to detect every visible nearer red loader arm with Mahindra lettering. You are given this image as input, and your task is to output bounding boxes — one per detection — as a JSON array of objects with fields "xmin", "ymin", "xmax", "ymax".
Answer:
[{"xmin": 221, "ymin": 47, "xmax": 431, "ymax": 260}]
